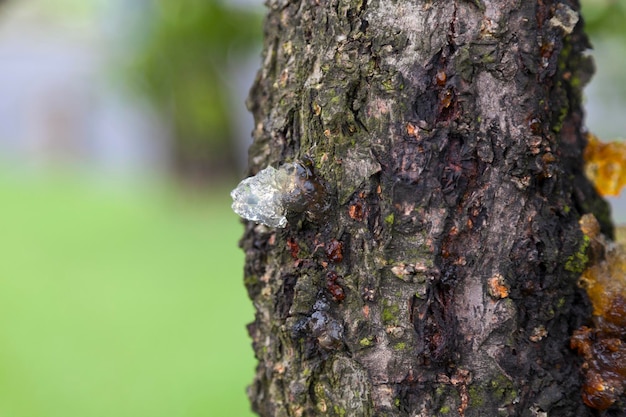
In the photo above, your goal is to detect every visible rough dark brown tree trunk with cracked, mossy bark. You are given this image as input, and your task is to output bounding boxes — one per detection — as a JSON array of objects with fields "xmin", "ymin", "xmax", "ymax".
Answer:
[{"xmin": 241, "ymin": 0, "xmax": 623, "ymax": 417}]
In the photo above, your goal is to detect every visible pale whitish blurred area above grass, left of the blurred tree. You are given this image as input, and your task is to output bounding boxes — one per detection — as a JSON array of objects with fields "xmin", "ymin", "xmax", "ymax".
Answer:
[{"xmin": 0, "ymin": 0, "xmax": 168, "ymax": 174}]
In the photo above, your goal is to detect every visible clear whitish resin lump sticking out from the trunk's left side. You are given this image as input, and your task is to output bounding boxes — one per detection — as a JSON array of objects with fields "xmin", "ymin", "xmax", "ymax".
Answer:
[{"xmin": 230, "ymin": 164, "xmax": 294, "ymax": 227}]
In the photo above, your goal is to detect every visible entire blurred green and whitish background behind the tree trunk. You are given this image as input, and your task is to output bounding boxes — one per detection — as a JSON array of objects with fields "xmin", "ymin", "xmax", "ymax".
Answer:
[{"xmin": 0, "ymin": 0, "xmax": 626, "ymax": 417}]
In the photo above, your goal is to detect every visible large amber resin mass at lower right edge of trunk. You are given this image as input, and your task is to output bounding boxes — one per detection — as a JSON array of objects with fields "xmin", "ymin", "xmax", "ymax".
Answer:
[{"xmin": 570, "ymin": 214, "xmax": 626, "ymax": 410}]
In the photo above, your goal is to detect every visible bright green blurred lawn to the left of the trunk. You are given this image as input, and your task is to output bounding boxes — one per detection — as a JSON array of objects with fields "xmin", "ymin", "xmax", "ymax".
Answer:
[{"xmin": 0, "ymin": 172, "xmax": 254, "ymax": 417}]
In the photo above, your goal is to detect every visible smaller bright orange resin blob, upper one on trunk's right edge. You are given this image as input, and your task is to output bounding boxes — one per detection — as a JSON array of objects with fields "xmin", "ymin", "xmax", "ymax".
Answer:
[{"xmin": 584, "ymin": 133, "xmax": 626, "ymax": 196}]
